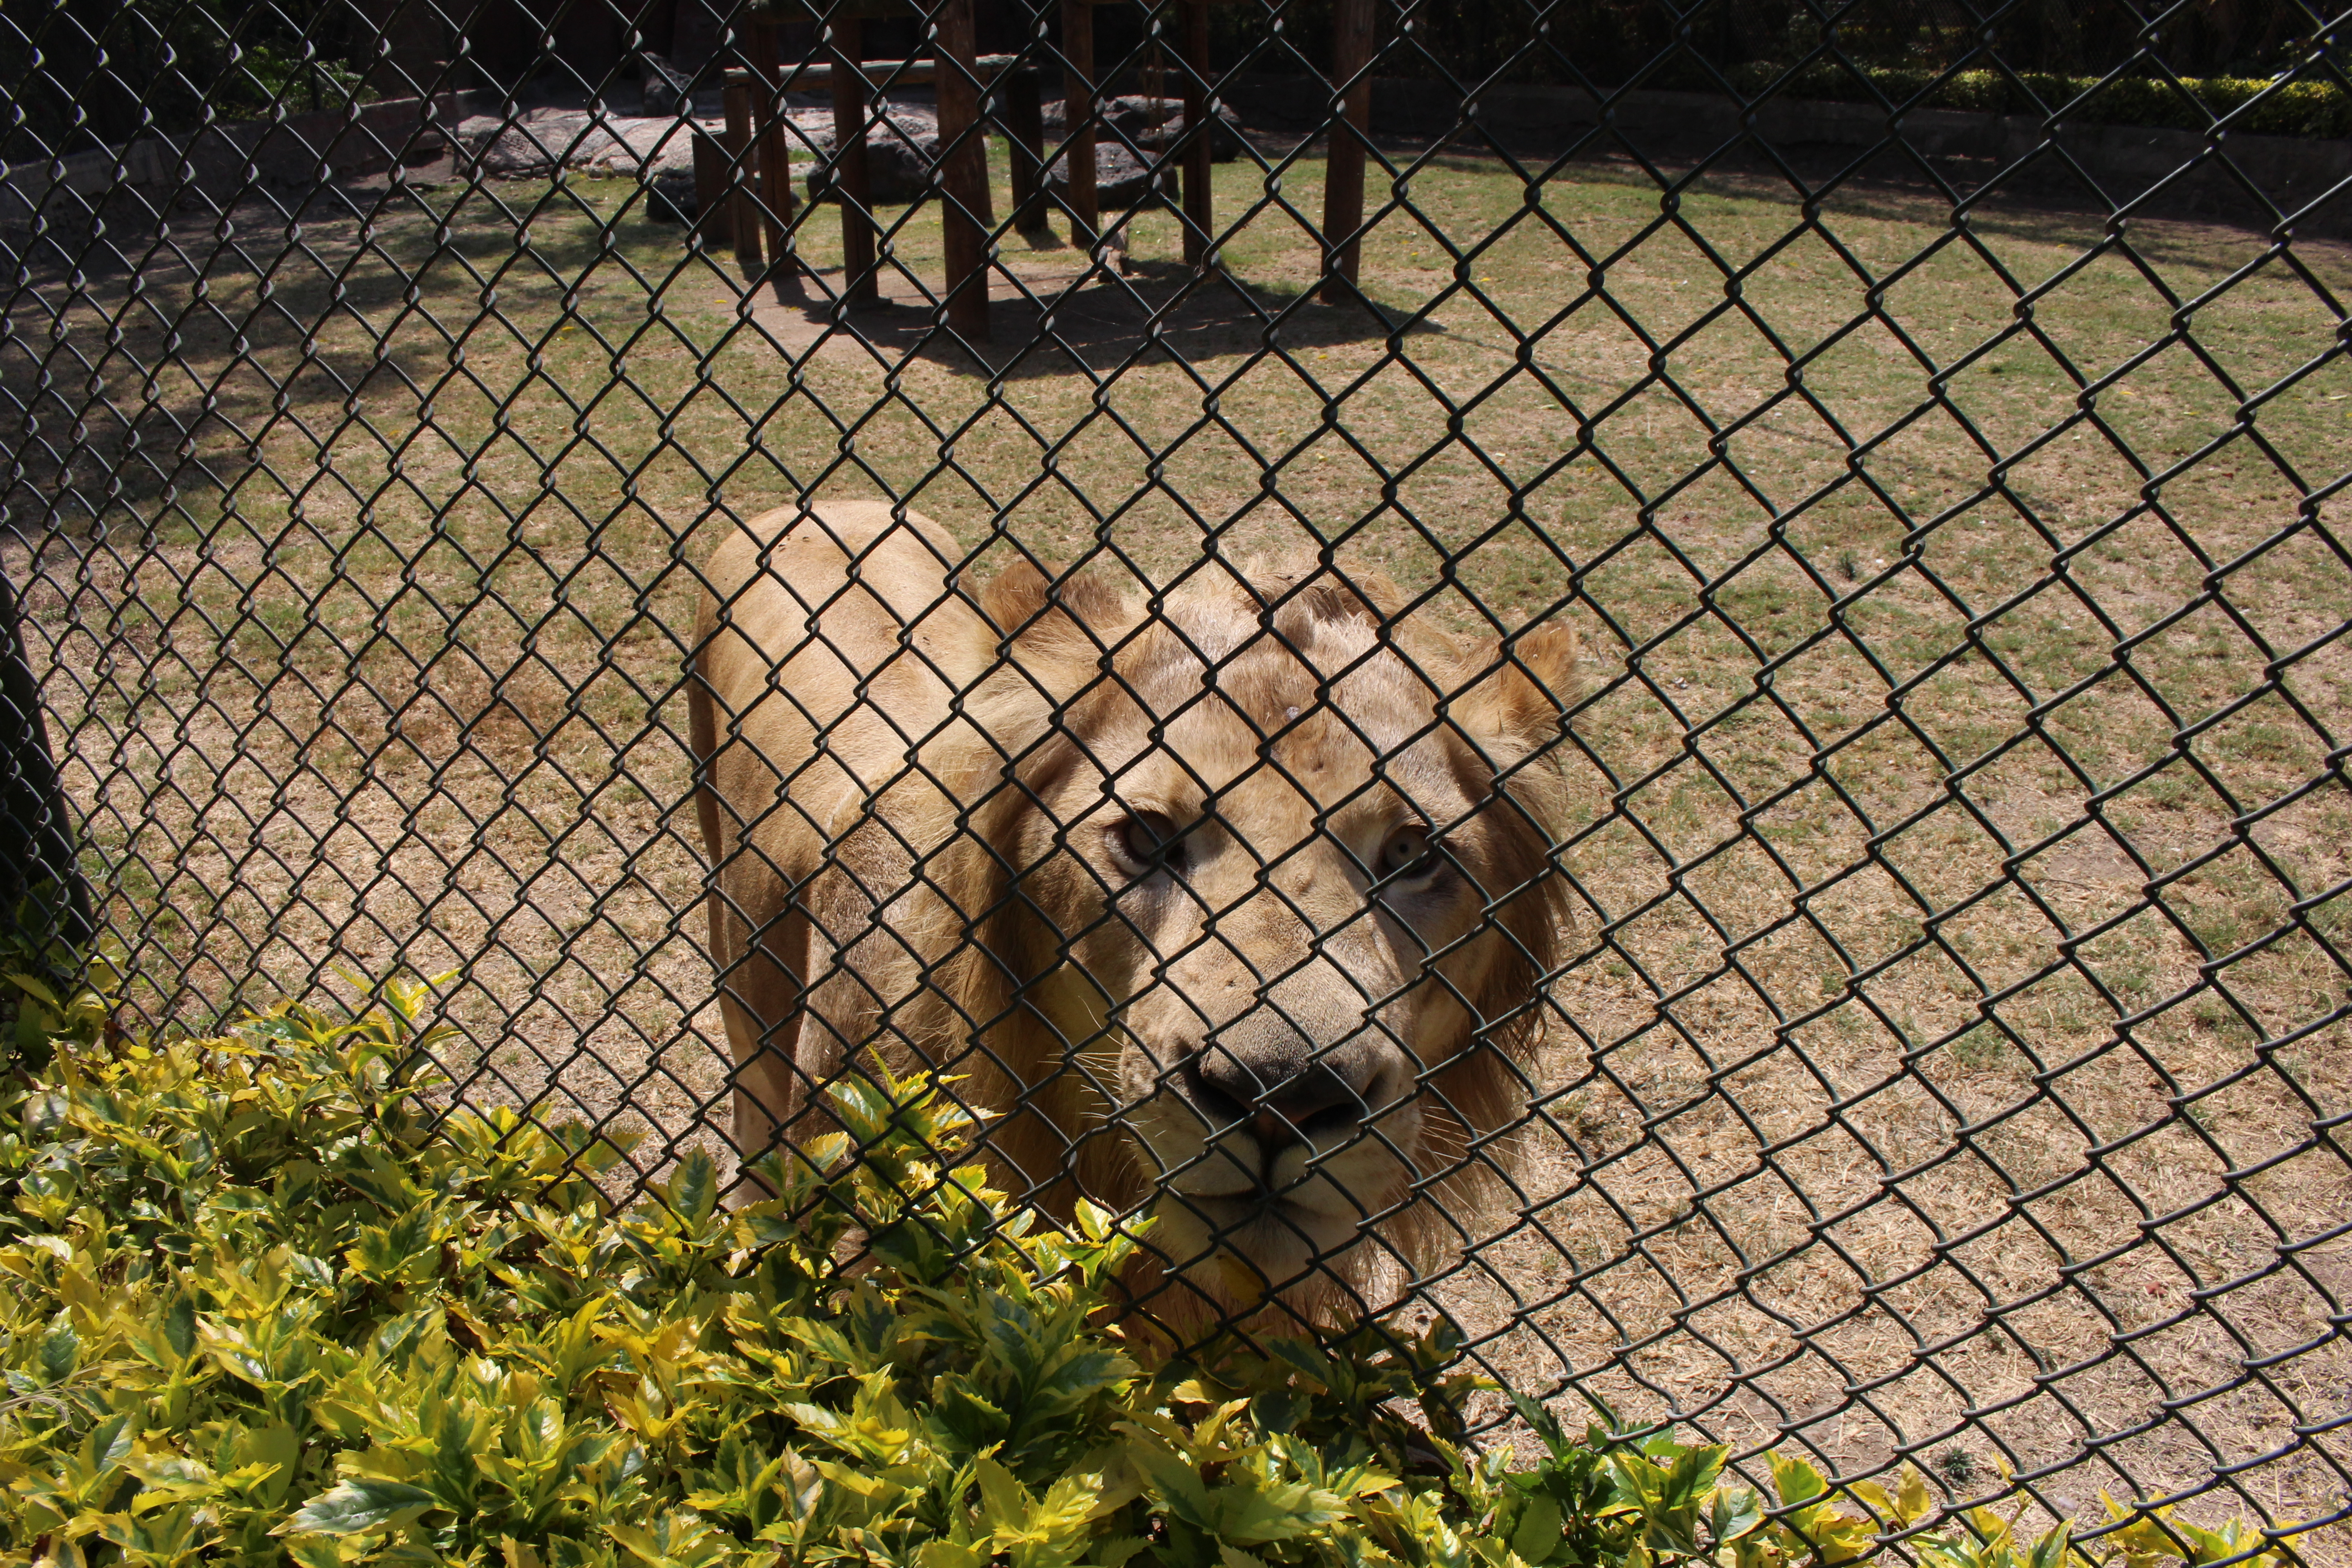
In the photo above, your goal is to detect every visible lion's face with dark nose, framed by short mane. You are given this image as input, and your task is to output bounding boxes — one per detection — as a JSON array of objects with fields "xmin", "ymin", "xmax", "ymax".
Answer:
[{"xmin": 964, "ymin": 564, "xmax": 1590, "ymax": 1300}]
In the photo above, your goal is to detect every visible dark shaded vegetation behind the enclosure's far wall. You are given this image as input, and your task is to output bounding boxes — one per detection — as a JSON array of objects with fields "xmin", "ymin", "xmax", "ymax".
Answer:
[{"xmin": 0, "ymin": 0, "xmax": 2342, "ymax": 160}]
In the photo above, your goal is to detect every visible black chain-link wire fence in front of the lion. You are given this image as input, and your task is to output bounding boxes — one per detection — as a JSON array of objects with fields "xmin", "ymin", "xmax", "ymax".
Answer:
[{"xmin": 0, "ymin": 0, "xmax": 2352, "ymax": 1561}]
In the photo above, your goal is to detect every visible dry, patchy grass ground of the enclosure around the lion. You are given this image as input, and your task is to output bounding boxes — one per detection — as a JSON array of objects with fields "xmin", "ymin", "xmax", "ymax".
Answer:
[{"xmin": 14, "ymin": 135, "xmax": 2352, "ymax": 1561}]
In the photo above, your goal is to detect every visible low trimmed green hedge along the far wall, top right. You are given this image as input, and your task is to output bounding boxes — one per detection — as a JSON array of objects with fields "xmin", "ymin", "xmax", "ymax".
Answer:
[{"xmin": 1731, "ymin": 61, "xmax": 2352, "ymax": 137}]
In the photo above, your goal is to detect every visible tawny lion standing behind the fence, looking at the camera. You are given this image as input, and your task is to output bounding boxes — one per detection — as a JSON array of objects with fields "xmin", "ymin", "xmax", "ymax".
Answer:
[{"xmin": 689, "ymin": 503, "xmax": 1576, "ymax": 1319}]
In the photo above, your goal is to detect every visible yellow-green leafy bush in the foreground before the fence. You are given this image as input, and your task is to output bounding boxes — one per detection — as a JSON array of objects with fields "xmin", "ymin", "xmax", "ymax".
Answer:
[{"xmin": 0, "ymin": 987, "xmax": 2323, "ymax": 1568}]
